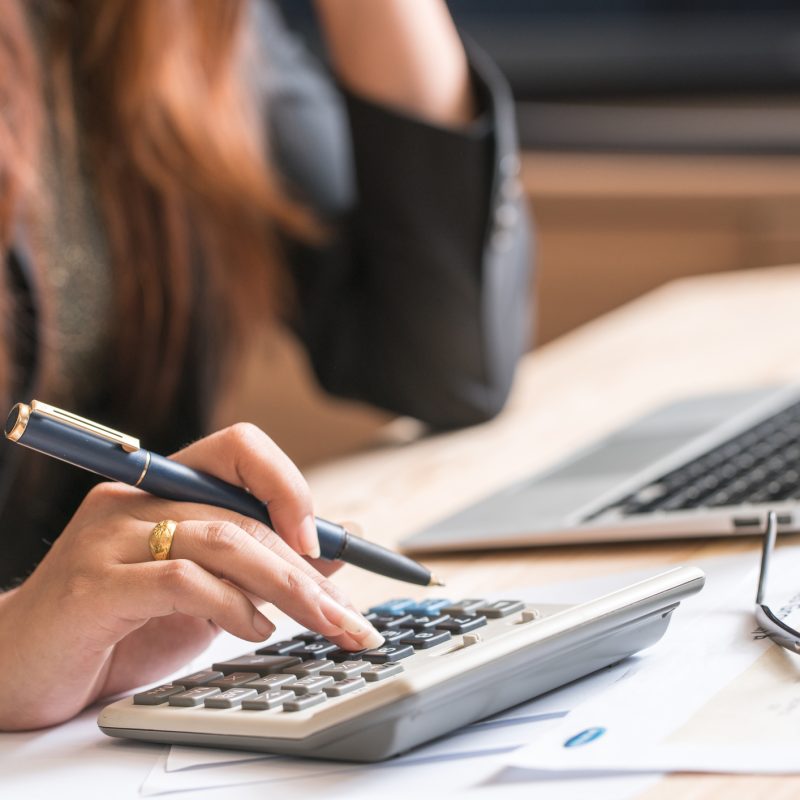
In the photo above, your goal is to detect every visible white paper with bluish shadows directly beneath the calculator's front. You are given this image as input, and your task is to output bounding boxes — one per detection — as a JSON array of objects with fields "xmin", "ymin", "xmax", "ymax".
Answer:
[{"xmin": 142, "ymin": 664, "xmax": 656, "ymax": 800}]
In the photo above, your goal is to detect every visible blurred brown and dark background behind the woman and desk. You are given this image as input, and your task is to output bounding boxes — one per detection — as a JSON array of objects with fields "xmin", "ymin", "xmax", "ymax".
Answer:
[{"xmin": 220, "ymin": 0, "xmax": 800, "ymax": 466}]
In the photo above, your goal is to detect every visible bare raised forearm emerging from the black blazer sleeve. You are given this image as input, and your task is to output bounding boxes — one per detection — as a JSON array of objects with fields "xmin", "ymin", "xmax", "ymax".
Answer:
[{"xmin": 316, "ymin": 0, "xmax": 475, "ymax": 126}]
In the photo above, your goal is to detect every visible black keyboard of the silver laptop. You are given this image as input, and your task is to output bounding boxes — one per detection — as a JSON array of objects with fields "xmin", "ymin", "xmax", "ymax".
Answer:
[{"xmin": 587, "ymin": 402, "xmax": 800, "ymax": 520}]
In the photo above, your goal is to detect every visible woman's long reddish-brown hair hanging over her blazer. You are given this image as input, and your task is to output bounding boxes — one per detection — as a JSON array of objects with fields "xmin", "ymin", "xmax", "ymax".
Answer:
[{"xmin": 0, "ymin": 0, "xmax": 314, "ymax": 428}]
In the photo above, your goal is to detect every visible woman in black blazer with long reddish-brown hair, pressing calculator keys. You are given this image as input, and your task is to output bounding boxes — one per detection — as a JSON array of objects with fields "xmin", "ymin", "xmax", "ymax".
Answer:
[{"xmin": 0, "ymin": 0, "xmax": 527, "ymax": 730}]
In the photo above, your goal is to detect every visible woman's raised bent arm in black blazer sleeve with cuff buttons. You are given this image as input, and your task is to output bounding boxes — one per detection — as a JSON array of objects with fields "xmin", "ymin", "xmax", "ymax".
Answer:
[{"xmin": 254, "ymin": 0, "xmax": 530, "ymax": 428}]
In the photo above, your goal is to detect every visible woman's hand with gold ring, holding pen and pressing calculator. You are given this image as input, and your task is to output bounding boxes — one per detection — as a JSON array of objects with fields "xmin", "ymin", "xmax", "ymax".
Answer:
[{"xmin": 0, "ymin": 425, "xmax": 383, "ymax": 730}]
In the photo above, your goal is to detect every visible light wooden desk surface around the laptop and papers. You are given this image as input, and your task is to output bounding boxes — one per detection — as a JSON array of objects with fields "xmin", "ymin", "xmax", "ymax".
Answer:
[{"xmin": 308, "ymin": 267, "xmax": 800, "ymax": 799}]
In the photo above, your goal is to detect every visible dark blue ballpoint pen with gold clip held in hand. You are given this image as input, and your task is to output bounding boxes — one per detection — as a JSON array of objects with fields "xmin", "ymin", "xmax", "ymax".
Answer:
[{"xmin": 5, "ymin": 400, "xmax": 444, "ymax": 586}]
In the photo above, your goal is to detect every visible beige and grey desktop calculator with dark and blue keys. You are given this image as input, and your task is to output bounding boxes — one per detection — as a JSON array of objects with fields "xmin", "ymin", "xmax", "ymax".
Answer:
[{"xmin": 98, "ymin": 566, "xmax": 705, "ymax": 762}]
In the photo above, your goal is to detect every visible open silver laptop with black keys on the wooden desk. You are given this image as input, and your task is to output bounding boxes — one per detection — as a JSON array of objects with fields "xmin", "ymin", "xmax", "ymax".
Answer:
[{"xmin": 401, "ymin": 385, "xmax": 800, "ymax": 553}]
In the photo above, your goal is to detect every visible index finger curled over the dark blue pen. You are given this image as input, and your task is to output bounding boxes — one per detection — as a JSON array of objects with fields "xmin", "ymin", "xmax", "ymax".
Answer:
[{"xmin": 171, "ymin": 422, "xmax": 320, "ymax": 558}]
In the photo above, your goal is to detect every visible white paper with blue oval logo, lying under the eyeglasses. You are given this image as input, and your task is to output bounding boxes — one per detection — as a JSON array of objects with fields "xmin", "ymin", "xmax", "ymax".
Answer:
[{"xmin": 508, "ymin": 545, "xmax": 800, "ymax": 774}]
